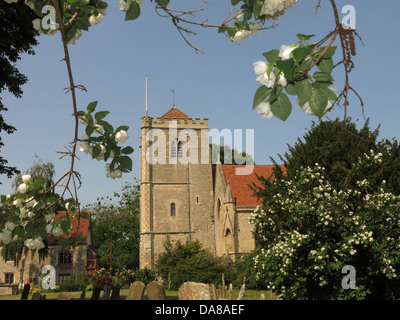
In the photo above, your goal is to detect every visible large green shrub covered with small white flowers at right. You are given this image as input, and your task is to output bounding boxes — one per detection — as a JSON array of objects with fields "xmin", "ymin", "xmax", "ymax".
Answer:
[{"xmin": 251, "ymin": 150, "xmax": 400, "ymax": 299}]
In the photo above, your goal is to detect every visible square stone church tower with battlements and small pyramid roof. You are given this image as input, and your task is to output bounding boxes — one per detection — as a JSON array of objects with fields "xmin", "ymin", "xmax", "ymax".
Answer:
[{"xmin": 140, "ymin": 106, "xmax": 215, "ymax": 269}]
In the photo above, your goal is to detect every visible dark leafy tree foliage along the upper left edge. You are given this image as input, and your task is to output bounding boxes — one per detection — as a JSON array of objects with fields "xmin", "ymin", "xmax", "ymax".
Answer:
[{"xmin": 0, "ymin": 1, "xmax": 39, "ymax": 183}]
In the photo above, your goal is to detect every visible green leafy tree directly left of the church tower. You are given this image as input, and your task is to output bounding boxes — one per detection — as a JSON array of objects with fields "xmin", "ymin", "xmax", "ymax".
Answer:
[{"xmin": 86, "ymin": 184, "xmax": 140, "ymax": 270}]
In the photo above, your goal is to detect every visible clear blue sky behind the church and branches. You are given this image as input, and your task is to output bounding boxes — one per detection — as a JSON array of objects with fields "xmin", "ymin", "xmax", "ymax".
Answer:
[{"xmin": 0, "ymin": 0, "xmax": 400, "ymax": 204}]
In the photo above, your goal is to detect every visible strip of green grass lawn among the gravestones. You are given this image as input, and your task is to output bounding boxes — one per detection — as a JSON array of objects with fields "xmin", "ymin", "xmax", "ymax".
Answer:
[{"xmin": 0, "ymin": 289, "xmax": 275, "ymax": 300}]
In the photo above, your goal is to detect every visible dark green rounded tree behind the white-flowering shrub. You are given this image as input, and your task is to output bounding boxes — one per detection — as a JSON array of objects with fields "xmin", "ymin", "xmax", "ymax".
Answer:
[{"xmin": 254, "ymin": 118, "xmax": 400, "ymax": 198}]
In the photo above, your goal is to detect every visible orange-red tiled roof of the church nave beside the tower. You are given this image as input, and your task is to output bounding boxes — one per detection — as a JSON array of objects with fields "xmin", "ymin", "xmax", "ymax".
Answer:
[{"xmin": 222, "ymin": 165, "xmax": 286, "ymax": 206}]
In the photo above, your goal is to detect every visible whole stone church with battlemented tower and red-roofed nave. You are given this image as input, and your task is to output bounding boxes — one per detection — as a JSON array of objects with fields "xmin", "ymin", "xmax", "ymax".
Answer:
[{"xmin": 140, "ymin": 106, "xmax": 282, "ymax": 269}]
